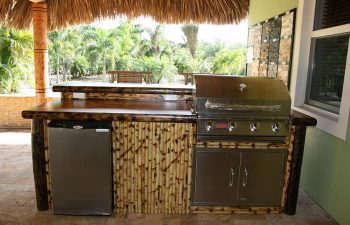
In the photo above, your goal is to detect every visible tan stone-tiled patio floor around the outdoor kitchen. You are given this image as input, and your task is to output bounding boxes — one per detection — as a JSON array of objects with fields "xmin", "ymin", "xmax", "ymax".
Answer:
[{"xmin": 0, "ymin": 129, "xmax": 337, "ymax": 225}]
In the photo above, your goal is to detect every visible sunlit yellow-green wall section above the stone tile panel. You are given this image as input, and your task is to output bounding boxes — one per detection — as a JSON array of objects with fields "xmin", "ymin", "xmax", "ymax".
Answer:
[{"xmin": 248, "ymin": 0, "xmax": 298, "ymax": 25}]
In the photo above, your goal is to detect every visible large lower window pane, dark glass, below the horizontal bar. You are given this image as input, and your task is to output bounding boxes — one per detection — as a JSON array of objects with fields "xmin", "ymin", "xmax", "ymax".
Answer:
[{"xmin": 306, "ymin": 35, "xmax": 349, "ymax": 114}]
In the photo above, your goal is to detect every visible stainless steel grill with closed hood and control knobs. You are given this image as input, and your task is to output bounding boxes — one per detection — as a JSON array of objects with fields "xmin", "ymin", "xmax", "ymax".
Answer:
[{"xmin": 195, "ymin": 75, "xmax": 291, "ymax": 141}]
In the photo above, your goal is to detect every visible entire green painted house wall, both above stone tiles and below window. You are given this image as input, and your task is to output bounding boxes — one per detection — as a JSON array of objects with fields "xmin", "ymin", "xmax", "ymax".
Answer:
[{"xmin": 249, "ymin": 0, "xmax": 350, "ymax": 225}]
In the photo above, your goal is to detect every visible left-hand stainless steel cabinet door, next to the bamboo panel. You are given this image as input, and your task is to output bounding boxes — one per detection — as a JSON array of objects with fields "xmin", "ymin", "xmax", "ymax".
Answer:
[{"xmin": 191, "ymin": 148, "xmax": 240, "ymax": 206}]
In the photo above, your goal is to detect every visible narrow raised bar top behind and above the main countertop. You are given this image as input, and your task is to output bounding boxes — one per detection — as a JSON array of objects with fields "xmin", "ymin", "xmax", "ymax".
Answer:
[{"xmin": 52, "ymin": 81, "xmax": 195, "ymax": 95}]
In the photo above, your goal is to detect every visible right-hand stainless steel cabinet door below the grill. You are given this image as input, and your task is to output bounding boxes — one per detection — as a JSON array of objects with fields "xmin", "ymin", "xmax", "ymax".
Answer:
[{"xmin": 238, "ymin": 150, "xmax": 287, "ymax": 206}]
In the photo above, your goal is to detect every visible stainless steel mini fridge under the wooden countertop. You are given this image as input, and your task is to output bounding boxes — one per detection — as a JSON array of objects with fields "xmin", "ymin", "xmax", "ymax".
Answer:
[{"xmin": 48, "ymin": 121, "xmax": 113, "ymax": 215}]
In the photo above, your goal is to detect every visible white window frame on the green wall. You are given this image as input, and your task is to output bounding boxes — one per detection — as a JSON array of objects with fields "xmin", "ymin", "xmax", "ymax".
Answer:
[{"xmin": 291, "ymin": 0, "xmax": 350, "ymax": 140}]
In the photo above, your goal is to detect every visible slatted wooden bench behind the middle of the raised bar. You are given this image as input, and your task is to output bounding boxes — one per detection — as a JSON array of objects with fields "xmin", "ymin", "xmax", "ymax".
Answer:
[{"xmin": 108, "ymin": 71, "xmax": 152, "ymax": 84}]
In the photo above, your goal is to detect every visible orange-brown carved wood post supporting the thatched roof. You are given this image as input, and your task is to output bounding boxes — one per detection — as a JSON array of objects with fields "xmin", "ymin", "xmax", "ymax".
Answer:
[{"xmin": 32, "ymin": 3, "xmax": 49, "ymax": 104}]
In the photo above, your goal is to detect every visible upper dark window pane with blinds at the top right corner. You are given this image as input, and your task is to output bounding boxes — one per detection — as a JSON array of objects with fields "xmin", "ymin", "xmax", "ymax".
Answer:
[{"xmin": 314, "ymin": 0, "xmax": 350, "ymax": 30}]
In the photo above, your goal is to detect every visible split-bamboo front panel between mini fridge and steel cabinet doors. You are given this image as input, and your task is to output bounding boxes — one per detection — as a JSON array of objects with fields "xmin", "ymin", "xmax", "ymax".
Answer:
[{"xmin": 112, "ymin": 121, "xmax": 195, "ymax": 214}]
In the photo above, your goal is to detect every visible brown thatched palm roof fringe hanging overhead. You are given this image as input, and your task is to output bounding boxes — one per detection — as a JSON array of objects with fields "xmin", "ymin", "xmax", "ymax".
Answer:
[{"xmin": 0, "ymin": 0, "xmax": 249, "ymax": 30}]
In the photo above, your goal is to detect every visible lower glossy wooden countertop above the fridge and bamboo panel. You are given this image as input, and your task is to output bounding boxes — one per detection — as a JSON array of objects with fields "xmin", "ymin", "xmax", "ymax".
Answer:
[{"xmin": 22, "ymin": 100, "xmax": 196, "ymax": 123}]
